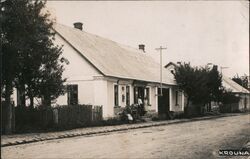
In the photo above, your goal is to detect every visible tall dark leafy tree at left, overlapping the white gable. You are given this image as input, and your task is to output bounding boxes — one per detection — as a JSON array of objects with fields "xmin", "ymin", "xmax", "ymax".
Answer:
[{"xmin": 1, "ymin": 0, "xmax": 65, "ymax": 133}]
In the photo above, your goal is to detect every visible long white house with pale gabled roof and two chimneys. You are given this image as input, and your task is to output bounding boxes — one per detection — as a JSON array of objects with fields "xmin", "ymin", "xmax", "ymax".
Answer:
[{"xmin": 13, "ymin": 22, "xmax": 184, "ymax": 117}]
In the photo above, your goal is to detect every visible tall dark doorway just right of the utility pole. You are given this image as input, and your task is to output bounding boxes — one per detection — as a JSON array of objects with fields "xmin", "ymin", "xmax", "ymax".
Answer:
[{"xmin": 158, "ymin": 88, "xmax": 169, "ymax": 115}]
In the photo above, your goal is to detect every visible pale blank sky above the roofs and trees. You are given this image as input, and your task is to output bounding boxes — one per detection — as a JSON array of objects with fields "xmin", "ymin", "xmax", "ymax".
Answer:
[{"xmin": 47, "ymin": 1, "xmax": 249, "ymax": 77}]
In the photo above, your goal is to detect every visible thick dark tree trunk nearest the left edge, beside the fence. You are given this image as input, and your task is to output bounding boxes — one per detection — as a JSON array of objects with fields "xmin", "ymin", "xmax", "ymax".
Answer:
[{"xmin": 5, "ymin": 83, "xmax": 12, "ymax": 134}]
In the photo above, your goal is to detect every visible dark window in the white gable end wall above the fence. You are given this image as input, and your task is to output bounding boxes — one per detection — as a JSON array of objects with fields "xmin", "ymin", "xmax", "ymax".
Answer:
[{"xmin": 67, "ymin": 84, "xmax": 78, "ymax": 105}]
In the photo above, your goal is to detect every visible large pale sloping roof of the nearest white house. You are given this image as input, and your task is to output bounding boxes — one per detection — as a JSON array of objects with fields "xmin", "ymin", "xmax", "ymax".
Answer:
[{"xmin": 54, "ymin": 24, "xmax": 175, "ymax": 85}]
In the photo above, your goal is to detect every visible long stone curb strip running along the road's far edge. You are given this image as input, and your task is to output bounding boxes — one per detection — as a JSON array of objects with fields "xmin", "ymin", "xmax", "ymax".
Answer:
[{"xmin": 1, "ymin": 114, "xmax": 245, "ymax": 147}]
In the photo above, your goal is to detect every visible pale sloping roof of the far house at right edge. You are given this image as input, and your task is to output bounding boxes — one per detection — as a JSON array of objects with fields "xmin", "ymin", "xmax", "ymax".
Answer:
[{"xmin": 222, "ymin": 75, "xmax": 250, "ymax": 93}]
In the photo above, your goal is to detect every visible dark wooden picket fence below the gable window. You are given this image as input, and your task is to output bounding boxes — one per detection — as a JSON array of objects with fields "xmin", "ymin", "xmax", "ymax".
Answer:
[{"xmin": 15, "ymin": 105, "xmax": 102, "ymax": 130}]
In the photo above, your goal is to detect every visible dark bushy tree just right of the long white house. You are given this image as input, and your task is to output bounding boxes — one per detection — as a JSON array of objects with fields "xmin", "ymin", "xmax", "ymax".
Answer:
[{"xmin": 174, "ymin": 63, "xmax": 222, "ymax": 113}]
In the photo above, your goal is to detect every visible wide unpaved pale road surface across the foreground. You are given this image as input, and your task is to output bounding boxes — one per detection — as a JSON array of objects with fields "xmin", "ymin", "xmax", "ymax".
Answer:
[{"xmin": 1, "ymin": 115, "xmax": 250, "ymax": 159}]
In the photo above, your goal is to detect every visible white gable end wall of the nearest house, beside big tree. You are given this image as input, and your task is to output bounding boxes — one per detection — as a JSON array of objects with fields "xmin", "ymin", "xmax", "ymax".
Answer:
[{"xmin": 55, "ymin": 34, "xmax": 101, "ymax": 105}]
